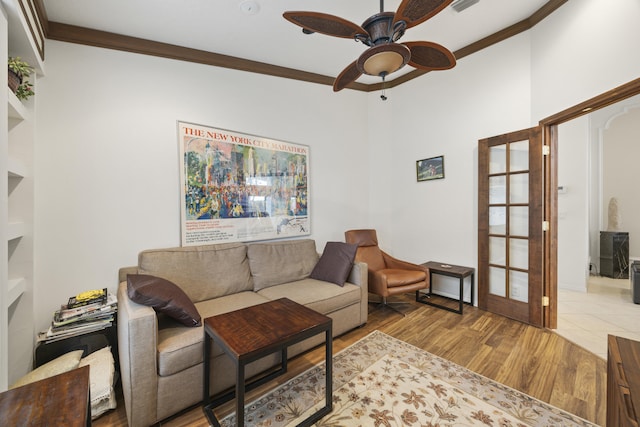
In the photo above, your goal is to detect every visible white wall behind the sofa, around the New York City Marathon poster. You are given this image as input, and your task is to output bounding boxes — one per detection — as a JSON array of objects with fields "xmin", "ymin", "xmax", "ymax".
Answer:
[{"xmin": 35, "ymin": 41, "xmax": 368, "ymax": 329}]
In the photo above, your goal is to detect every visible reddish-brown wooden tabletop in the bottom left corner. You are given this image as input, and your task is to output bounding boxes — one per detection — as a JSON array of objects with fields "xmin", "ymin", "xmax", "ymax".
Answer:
[{"xmin": 0, "ymin": 366, "xmax": 91, "ymax": 427}]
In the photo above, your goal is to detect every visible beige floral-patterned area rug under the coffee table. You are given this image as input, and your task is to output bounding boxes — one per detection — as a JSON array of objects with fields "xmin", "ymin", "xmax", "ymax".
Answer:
[{"xmin": 221, "ymin": 331, "xmax": 595, "ymax": 427}]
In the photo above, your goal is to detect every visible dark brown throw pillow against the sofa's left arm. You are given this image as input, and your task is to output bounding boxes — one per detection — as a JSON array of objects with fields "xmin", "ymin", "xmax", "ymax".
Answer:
[{"xmin": 127, "ymin": 274, "xmax": 200, "ymax": 326}]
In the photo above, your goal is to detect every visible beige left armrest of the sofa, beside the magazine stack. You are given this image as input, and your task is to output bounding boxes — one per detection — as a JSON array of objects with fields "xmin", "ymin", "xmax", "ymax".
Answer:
[{"xmin": 118, "ymin": 276, "xmax": 158, "ymax": 427}]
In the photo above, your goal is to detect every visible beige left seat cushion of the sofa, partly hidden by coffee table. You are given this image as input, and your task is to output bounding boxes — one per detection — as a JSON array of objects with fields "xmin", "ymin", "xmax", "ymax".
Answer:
[{"xmin": 158, "ymin": 292, "xmax": 268, "ymax": 377}]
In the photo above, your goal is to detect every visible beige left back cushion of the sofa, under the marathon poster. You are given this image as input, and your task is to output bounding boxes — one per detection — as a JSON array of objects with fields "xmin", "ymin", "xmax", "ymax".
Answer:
[{"xmin": 138, "ymin": 243, "xmax": 253, "ymax": 302}]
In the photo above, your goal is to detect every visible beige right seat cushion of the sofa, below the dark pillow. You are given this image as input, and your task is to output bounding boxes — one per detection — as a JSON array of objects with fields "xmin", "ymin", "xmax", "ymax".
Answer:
[{"xmin": 258, "ymin": 278, "xmax": 362, "ymax": 314}]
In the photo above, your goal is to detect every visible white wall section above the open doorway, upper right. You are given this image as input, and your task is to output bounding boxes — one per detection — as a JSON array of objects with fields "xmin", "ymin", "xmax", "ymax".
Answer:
[{"xmin": 531, "ymin": 0, "xmax": 640, "ymax": 122}]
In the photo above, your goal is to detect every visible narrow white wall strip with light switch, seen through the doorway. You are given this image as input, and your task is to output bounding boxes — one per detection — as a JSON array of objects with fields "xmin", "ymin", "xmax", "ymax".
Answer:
[{"xmin": 558, "ymin": 116, "xmax": 590, "ymax": 291}]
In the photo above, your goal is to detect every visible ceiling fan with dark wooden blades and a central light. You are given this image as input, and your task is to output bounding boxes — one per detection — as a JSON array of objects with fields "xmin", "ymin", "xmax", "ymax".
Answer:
[{"xmin": 283, "ymin": 0, "xmax": 456, "ymax": 92}]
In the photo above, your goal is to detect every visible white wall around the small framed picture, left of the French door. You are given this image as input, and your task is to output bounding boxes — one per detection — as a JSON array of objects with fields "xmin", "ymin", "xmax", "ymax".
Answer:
[{"xmin": 362, "ymin": 34, "xmax": 531, "ymax": 299}]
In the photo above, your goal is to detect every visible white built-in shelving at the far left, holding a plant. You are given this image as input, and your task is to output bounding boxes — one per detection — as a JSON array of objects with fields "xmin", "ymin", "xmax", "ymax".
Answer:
[{"xmin": 0, "ymin": 0, "xmax": 44, "ymax": 392}]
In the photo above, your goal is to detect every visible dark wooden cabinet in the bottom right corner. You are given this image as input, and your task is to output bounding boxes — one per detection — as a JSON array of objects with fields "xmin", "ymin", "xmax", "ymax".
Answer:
[{"xmin": 607, "ymin": 335, "xmax": 640, "ymax": 427}]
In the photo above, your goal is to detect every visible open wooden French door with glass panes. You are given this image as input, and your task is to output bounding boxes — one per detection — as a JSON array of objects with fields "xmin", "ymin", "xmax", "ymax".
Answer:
[{"xmin": 478, "ymin": 127, "xmax": 545, "ymax": 327}]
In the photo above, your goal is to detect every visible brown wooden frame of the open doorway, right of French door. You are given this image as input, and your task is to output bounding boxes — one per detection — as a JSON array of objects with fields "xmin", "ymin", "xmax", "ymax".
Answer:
[{"xmin": 539, "ymin": 78, "xmax": 640, "ymax": 329}]
